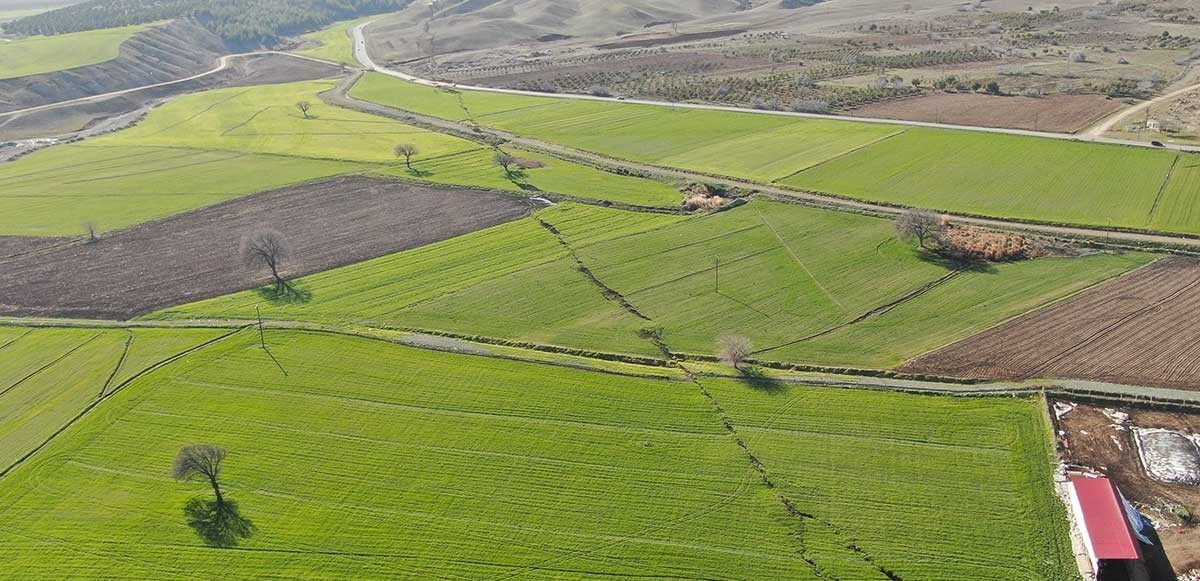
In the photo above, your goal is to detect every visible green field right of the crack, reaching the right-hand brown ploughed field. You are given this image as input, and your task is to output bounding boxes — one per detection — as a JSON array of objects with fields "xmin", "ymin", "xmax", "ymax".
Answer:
[{"xmin": 563, "ymin": 202, "xmax": 1152, "ymax": 367}]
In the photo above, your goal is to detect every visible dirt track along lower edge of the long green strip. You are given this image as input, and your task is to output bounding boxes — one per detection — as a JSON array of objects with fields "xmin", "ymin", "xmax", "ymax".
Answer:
[{"xmin": 320, "ymin": 63, "xmax": 1200, "ymax": 252}]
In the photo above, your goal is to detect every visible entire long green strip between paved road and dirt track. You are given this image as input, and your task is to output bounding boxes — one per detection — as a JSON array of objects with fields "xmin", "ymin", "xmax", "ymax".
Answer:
[{"xmin": 353, "ymin": 74, "xmax": 1200, "ymax": 233}]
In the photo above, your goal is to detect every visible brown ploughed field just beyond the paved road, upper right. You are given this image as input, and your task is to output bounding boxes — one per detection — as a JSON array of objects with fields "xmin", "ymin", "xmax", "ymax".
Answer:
[{"xmin": 847, "ymin": 92, "xmax": 1122, "ymax": 133}]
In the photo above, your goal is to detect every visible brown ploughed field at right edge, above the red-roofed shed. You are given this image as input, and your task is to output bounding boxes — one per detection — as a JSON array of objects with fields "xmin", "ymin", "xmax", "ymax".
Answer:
[{"xmin": 902, "ymin": 258, "xmax": 1200, "ymax": 389}]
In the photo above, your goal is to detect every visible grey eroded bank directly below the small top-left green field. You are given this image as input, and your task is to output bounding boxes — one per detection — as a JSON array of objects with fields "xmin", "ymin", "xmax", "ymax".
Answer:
[{"xmin": 0, "ymin": 20, "xmax": 227, "ymax": 113}]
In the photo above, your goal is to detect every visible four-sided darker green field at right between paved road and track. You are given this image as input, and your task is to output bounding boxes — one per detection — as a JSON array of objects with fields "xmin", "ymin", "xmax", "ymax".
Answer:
[{"xmin": 784, "ymin": 128, "xmax": 1185, "ymax": 232}]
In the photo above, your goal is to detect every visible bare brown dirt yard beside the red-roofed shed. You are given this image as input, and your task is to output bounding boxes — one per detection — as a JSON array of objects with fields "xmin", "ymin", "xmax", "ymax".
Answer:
[{"xmin": 1055, "ymin": 400, "xmax": 1200, "ymax": 579}]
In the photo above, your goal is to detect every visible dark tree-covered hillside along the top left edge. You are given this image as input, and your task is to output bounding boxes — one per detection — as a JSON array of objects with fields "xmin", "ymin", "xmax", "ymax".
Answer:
[{"xmin": 2, "ymin": 0, "xmax": 412, "ymax": 47}]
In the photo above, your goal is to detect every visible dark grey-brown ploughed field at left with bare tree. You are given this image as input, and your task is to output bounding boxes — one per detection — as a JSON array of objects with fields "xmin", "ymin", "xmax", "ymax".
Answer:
[{"xmin": 0, "ymin": 176, "xmax": 530, "ymax": 319}]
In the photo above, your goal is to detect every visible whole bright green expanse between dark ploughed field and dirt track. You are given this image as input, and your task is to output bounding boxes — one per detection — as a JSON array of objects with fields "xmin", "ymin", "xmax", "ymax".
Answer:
[{"xmin": 0, "ymin": 83, "xmax": 682, "ymax": 236}]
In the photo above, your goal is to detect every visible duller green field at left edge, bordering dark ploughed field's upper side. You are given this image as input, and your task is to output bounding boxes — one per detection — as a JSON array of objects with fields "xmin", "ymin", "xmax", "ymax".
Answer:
[{"xmin": 0, "ymin": 144, "xmax": 364, "ymax": 236}]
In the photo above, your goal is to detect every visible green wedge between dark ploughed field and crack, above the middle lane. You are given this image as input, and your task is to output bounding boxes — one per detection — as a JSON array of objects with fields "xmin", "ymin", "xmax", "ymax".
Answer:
[{"xmin": 149, "ymin": 205, "xmax": 682, "ymax": 355}]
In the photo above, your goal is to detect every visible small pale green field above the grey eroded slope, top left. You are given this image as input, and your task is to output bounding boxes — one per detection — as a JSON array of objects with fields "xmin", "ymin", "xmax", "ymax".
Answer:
[{"xmin": 0, "ymin": 23, "xmax": 146, "ymax": 79}]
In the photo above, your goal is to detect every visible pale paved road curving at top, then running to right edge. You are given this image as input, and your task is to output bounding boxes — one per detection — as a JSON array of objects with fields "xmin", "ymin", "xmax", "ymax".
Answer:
[{"xmin": 352, "ymin": 20, "xmax": 1200, "ymax": 151}]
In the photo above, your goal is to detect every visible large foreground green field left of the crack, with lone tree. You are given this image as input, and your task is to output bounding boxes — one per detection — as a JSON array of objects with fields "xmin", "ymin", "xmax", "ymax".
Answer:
[{"xmin": 0, "ymin": 331, "xmax": 817, "ymax": 580}]
